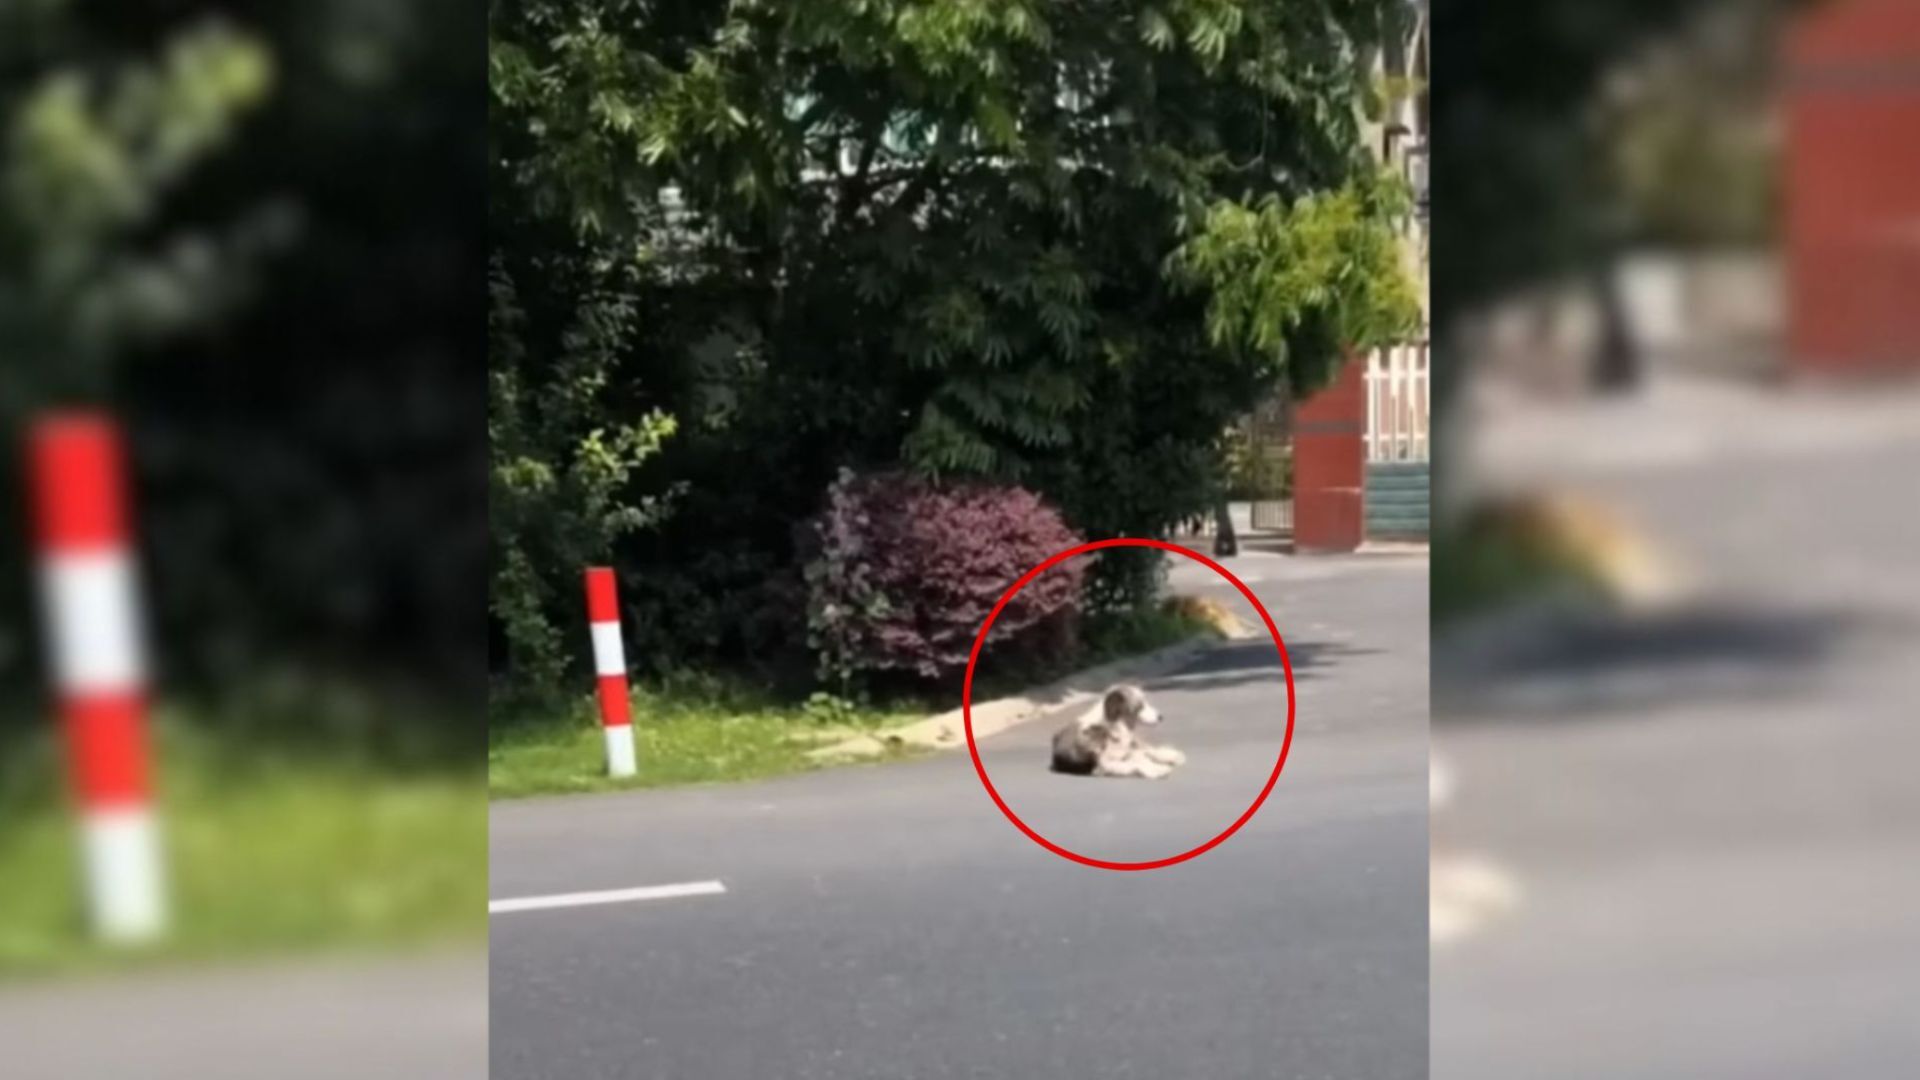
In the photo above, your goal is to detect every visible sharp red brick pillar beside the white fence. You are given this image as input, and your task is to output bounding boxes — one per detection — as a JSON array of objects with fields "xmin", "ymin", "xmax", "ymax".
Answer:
[{"xmin": 1294, "ymin": 357, "xmax": 1367, "ymax": 553}]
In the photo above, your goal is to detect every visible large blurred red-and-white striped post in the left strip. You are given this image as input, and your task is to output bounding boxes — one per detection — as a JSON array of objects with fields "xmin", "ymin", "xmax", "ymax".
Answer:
[{"xmin": 29, "ymin": 413, "xmax": 167, "ymax": 942}]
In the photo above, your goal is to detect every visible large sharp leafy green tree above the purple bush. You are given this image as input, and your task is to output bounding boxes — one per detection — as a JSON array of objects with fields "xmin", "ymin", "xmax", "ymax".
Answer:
[{"xmin": 493, "ymin": 0, "xmax": 1413, "ymax": 672}]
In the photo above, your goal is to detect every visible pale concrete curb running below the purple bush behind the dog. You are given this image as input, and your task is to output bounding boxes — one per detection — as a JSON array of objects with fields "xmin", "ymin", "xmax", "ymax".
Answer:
[{"xmin": 806, "ymin": 628, "xmax": 1248, "ymax": 761}]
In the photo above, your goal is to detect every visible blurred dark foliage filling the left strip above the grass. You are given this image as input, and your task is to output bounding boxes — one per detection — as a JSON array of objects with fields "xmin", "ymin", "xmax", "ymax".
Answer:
[{"xmin": 0, "ymin": 0, "xmax": 486, "ymax": 722}]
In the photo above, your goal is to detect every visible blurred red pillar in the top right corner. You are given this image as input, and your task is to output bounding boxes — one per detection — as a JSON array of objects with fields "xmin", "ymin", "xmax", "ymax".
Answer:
[{"xmin": 1784, "ymin": 0, "xmax": 1920, "ymax": 375}]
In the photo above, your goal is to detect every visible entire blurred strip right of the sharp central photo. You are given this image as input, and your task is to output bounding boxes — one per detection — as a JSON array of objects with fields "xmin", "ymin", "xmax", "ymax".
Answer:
[{"xmin": 1432, "ymin": 0, "xmax": 1920, "ymax": 1078}]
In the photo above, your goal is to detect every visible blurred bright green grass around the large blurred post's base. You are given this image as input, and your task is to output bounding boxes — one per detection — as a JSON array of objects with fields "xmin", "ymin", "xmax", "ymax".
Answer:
[{"xmin": 0, "ymin": 715, "xmax": 488, "ymax": 980}]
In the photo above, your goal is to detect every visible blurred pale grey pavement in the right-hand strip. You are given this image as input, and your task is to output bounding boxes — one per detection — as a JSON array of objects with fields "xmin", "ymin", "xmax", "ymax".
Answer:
[{"xmin": 1432, "ymin": 372, "xmax": 1920, "ymax": 1080}]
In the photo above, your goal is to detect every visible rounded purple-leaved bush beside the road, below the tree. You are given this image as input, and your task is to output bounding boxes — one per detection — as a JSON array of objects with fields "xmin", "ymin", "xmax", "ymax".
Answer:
[{"xmin": 806, "ymin": 471, "xmax": 1085, "ymax": 692}]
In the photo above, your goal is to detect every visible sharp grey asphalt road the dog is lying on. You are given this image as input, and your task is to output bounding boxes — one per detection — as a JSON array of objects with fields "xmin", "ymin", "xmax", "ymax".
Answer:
[{"xmin": 492, "ymin": 553, "xmax": 1428, "ymax": 1080}]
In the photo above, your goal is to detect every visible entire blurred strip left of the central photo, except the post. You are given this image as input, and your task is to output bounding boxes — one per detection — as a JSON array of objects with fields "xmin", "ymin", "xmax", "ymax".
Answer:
[{"xmin": 0, "ymin": 0, "xmax": 486, "ymax": 1076}]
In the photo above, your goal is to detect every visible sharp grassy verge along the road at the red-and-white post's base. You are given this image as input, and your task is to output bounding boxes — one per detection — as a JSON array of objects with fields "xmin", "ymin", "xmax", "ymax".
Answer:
[{"xmin": 488, "ymin": 605, "xmax": 1219, "ymax": 798}]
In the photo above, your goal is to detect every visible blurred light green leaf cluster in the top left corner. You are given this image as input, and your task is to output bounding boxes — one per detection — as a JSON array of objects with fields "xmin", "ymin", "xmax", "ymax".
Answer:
[{"xmin": 0, "ymin": 10, "xmax": 275, "ymax": 402}]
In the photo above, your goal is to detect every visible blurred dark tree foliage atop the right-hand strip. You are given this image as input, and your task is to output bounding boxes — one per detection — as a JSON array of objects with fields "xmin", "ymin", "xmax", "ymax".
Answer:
[{"xmin": 1432, "ymin": 0, "xmax": 1805, "ymax": 399}]
